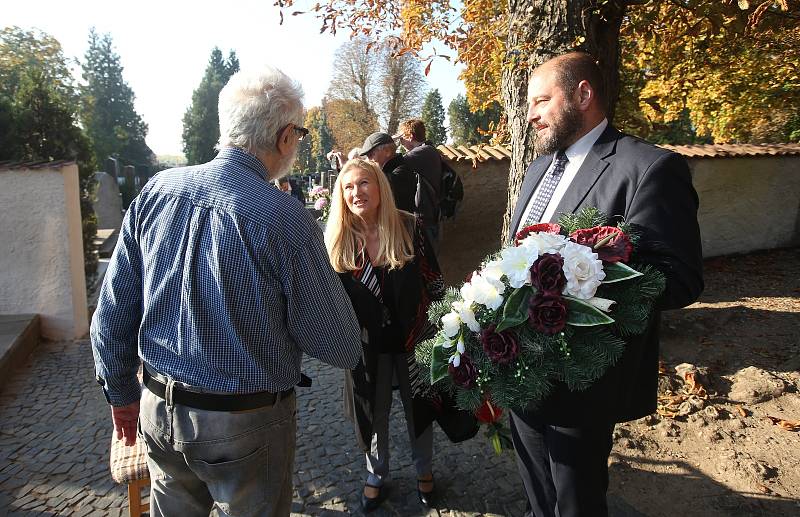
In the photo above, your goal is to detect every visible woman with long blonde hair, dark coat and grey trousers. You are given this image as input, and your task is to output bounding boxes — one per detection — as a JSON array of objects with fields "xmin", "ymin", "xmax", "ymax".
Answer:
[{"xmin": 325, "ymin": 158, "xmax": 444, "ymax": 512}]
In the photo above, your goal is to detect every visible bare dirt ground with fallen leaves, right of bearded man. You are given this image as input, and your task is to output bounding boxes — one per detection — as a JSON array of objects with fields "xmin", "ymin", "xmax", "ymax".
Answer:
[{"xmin": 609, "ymin": 249, "xmax": 800, "ymax": 516}]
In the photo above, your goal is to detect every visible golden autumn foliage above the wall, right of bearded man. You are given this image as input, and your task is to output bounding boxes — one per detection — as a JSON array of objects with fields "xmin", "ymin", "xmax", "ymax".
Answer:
[{"xmin": 617, "ymin": 0, "xmax": 800, "ymax": 142}]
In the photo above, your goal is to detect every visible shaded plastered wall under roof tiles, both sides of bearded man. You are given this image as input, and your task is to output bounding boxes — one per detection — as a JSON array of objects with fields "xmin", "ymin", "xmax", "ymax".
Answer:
[{"xmin": 439, "ymin": 155, "xmax": 800, "ymax": 285}]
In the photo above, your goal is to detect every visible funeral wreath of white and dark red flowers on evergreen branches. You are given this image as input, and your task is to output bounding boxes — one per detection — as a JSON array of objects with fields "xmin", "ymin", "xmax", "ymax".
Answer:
[{"xmin": 417, "ymin": 208, "xmax": 664, "ymax": 452}]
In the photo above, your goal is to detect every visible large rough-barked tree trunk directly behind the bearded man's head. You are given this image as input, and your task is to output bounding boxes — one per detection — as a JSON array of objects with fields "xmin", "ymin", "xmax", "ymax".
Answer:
[{"xmin": 501, "ymin": 0, "xmax": 626, "ymax": 243}]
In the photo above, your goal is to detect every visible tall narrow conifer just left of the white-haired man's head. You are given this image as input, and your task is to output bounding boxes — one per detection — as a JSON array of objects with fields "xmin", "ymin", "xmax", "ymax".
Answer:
[{"xmin": 183, "ymin": 47, "xmax": 239, "ymax": 165}]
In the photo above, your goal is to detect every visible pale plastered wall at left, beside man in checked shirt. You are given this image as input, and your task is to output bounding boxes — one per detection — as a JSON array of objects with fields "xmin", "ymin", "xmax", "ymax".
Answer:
[{"xmin": 0, "ymin": 164, "xmax": 88, "ymax": 339}]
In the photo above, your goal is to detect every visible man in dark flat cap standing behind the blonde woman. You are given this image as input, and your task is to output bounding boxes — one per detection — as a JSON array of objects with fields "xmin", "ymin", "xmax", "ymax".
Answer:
[{"xmin": 361, "ymin": 133, "xmax": 417, "ymax": 214}]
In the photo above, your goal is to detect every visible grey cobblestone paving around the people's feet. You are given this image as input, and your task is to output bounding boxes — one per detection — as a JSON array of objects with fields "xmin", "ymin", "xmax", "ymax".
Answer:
[{"xmin": 0, "ymin": 341, "xmax": 523, "ymax": 517}]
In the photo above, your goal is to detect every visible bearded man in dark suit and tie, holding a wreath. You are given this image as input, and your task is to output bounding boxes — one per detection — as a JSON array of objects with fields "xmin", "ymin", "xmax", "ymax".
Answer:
[{"xmin": 511, "ymin": 52, "xmax": 703, "ymax": 517}]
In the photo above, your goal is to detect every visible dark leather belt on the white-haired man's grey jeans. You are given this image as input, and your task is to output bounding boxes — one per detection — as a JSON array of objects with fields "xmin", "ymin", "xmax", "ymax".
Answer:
[{"xmin": 142, "ymin": 366, "xmax": 294, "ymax": 411}]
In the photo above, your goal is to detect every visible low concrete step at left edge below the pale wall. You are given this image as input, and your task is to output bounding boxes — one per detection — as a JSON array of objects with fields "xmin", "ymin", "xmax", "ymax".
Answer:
[{"xmin": 0, "ymin": 314, "xmax": 41, "ymax": 390}]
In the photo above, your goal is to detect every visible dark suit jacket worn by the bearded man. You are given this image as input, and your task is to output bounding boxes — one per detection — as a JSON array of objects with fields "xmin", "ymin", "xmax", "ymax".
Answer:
[{"xmin": 511, "ymin": 125, "xmax": 703, "ymax": 426}]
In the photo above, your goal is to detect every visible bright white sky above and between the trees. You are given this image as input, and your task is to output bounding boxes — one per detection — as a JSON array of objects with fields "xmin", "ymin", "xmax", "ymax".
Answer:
[{"xmin": 6, "ymin": 0, "xmax": 464, "ymax": 155}]
